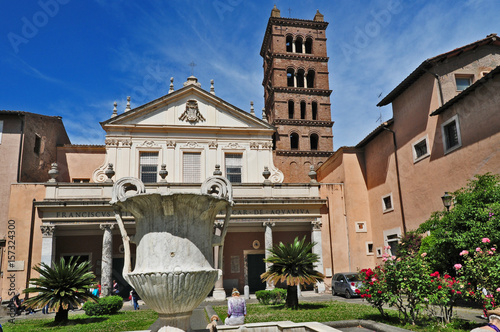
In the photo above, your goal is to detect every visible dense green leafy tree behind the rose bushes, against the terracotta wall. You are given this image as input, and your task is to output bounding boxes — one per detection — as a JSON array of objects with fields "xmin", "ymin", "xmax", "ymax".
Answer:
[{"xmin": 418, "ymin": 173, "xmax": 500, "ymax": 272}]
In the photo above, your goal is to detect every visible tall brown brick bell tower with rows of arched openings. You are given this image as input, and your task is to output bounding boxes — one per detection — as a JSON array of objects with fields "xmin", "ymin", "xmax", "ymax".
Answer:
[{"xmin": 260, "ymin": 5, "xmax": 333, "ymax": 183}]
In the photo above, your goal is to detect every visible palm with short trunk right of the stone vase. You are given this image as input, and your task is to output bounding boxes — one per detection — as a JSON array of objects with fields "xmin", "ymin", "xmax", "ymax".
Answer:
[{"xmin": 260, "ymin": 236, "xmax": 325, "ymax": 309}]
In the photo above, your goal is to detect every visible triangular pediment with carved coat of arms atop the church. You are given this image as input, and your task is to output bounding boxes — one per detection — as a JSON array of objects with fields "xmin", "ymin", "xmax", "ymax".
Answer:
[{"xmin": 101, "ymin": 85, "xmax": 274, "ymax": 131}]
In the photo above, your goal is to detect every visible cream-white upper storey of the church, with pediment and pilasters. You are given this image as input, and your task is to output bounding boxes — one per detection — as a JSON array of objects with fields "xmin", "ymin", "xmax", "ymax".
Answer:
[{"xmin": 93, "ymin": 77, "xmax": 283, "ymax": 183}]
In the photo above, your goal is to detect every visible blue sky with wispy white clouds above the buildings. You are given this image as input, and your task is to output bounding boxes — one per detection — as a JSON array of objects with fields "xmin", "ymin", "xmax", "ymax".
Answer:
[{"xmin": 0, "ymin": 0, "xmax": 500, "ymax": 150}]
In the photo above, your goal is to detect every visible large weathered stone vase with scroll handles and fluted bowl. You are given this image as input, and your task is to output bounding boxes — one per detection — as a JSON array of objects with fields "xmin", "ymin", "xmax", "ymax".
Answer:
[{"xmin": 111, "ymin": 176, "xmax": 233, "ymax": 331}]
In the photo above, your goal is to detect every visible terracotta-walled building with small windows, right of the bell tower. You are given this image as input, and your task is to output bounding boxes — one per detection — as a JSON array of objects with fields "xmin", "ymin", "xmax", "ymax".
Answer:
[{"xmin": 318, "ymin": 34, "xmax": 500, "ymax": 272}]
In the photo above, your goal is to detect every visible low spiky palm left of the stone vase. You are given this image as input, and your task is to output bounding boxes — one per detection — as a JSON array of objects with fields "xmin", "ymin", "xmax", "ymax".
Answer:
[{"xmin": 24, "ymin": 257, "xmax": 97, "ymax": 322}]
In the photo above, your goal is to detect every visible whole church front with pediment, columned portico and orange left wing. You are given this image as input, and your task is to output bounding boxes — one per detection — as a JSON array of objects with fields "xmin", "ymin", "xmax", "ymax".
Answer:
[{"xmin": 2, "ymin": 65, "xmax": 325, "ymax": 298}]
